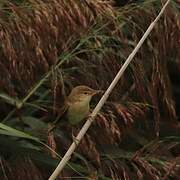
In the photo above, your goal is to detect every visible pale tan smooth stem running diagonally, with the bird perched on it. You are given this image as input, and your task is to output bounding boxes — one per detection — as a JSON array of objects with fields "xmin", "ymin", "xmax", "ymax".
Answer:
[{"xmin": 49, "ymin": 0, "xmax": 170, "ymax": 180}]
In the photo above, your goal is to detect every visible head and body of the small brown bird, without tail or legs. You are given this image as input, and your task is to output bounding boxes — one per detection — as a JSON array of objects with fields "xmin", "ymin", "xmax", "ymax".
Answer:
[{"xmin": 66, "ymin": 85, "xmax": 102, "ymax": 125}]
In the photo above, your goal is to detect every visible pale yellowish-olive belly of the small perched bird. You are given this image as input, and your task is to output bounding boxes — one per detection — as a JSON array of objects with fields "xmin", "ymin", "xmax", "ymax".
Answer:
[{"xmin": 67, "ymin": 104, "xmax": 89, "ymax": 125}]
